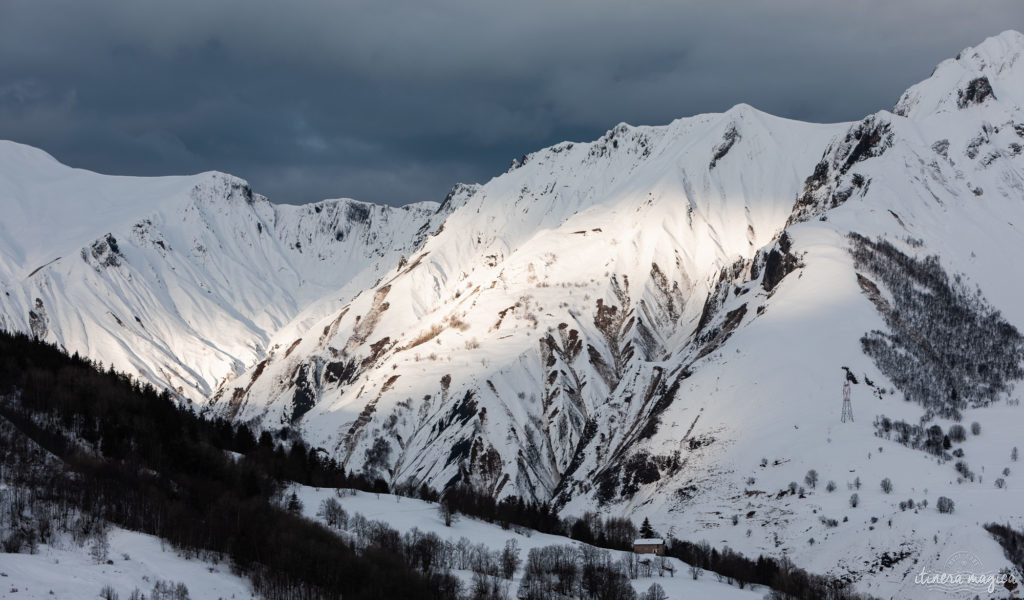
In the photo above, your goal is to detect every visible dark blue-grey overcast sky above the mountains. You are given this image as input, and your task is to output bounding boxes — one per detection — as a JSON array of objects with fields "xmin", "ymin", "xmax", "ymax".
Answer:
[{"xmin": 0, "ymin": 0, "xmax": 1024, "ymax": 205}]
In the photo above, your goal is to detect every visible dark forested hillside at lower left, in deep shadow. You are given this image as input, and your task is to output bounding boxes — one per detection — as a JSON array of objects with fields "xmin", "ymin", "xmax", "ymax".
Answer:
[{"xmin": 0, "ymin": 333, "xmax": 458, "ymax": 600}]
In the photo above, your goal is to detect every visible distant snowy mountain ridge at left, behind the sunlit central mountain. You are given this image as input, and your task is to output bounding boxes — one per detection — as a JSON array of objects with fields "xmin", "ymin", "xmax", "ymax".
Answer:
[{"xmin": 0, "ymin": 141, "xmax": 437, "ymax": 399}]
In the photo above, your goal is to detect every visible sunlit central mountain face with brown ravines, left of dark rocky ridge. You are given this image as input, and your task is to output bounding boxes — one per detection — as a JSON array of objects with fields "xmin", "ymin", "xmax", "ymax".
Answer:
[{"xmin": 214, "ymin": 105, "xmax": 846, "ymax": 479}]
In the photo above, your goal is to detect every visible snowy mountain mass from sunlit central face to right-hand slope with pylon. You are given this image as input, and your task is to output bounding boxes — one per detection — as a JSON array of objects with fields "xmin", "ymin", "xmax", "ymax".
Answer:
[{"xmin": 214, "ymin": 32, "xmax": 1024, "ymax": 598}]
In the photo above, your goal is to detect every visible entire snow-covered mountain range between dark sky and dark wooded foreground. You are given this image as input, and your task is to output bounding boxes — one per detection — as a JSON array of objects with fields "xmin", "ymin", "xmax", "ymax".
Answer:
[{"xmin": 6, "ymin": 32, "xmax": 1024, "ymax": 598}]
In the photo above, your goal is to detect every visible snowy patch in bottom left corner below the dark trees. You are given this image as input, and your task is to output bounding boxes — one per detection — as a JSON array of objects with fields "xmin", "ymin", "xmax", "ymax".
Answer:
[{"xmin": 0, "ymin": 527, "xmax": 253, "ymax": 600}]
